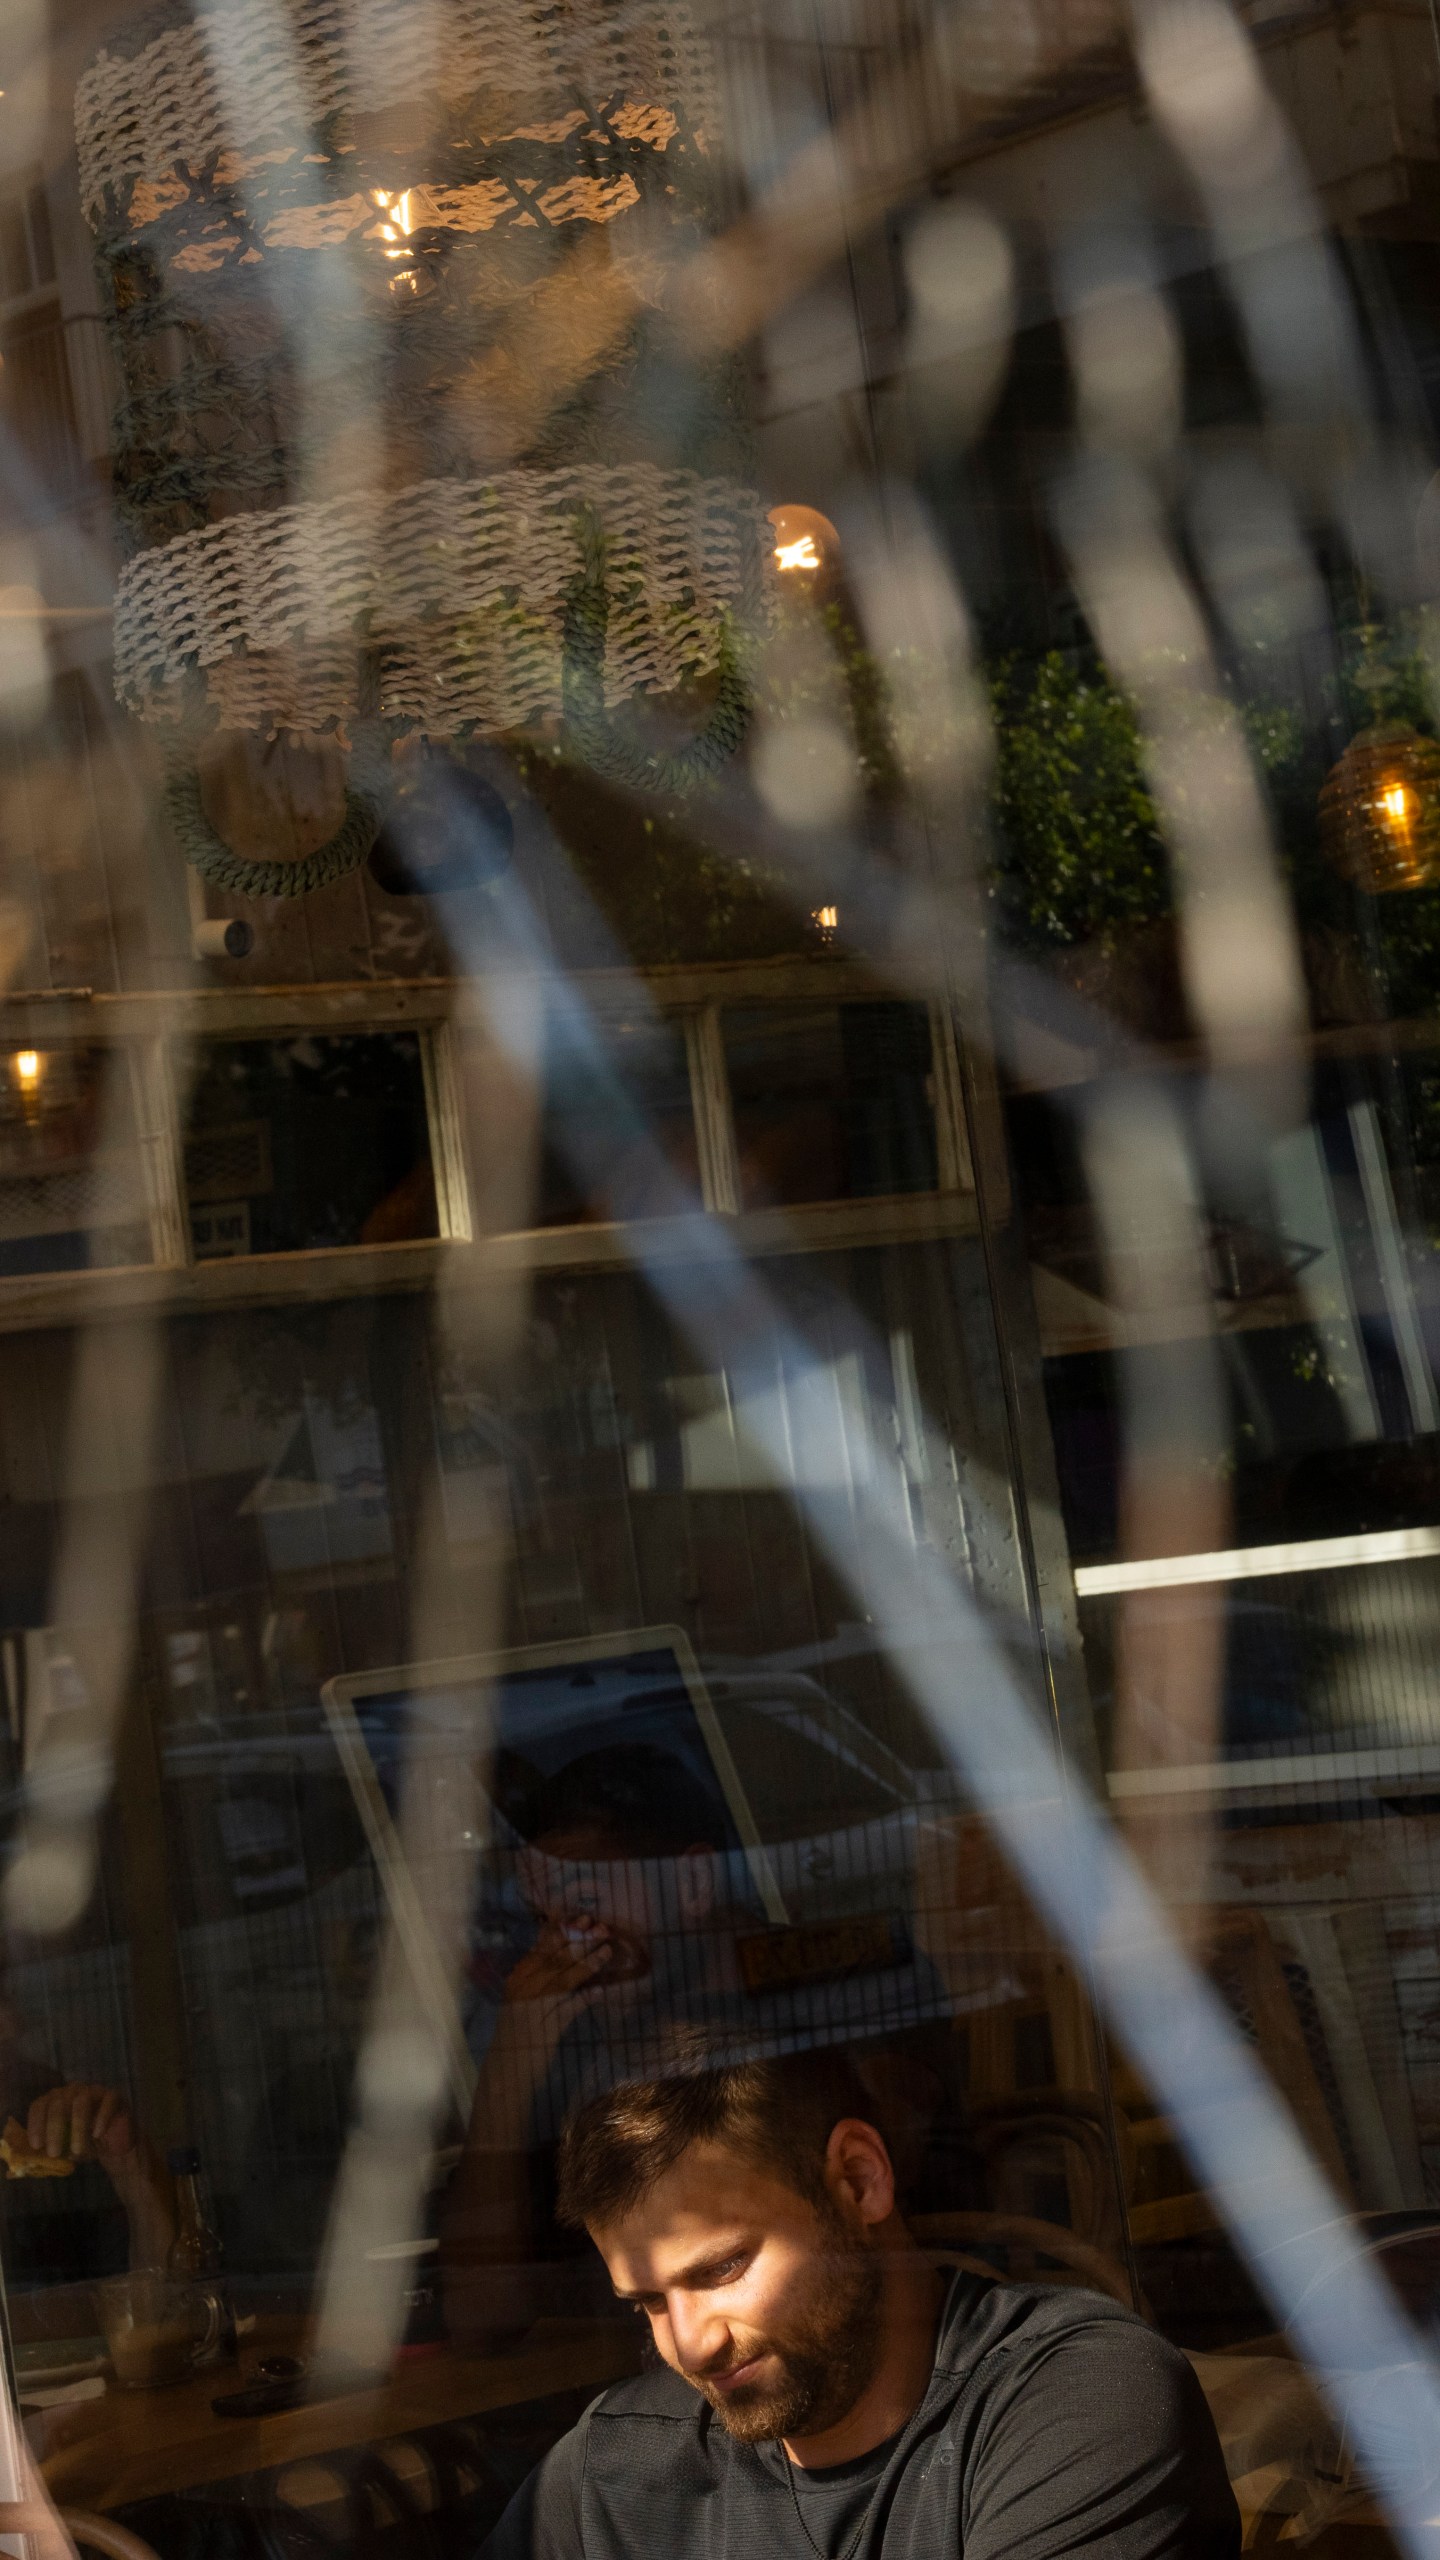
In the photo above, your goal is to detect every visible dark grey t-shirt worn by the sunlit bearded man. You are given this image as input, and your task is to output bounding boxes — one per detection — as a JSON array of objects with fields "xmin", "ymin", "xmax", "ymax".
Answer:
[{"xmin": 479, "ymin": 2273, "xmax": 1240, "ymax": 2560}]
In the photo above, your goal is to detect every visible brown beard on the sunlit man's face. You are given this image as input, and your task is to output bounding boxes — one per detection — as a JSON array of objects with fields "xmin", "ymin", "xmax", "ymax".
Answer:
[{"xmin": 684, "ymin": 2214, "xmax": 884, "ymax": 2445}]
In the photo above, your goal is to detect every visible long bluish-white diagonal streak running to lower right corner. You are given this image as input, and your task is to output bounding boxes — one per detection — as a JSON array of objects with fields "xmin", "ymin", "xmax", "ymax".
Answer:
[{"xmin": 461, "ymin": 888, "xmax": 1440, "ymax": 2560}]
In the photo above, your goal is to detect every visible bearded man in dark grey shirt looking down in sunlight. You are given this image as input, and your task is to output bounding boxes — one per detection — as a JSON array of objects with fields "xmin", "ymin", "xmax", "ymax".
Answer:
[{"xmin": 482, "ymin": 2053, "xmax": 1240, "ymax": 2560}]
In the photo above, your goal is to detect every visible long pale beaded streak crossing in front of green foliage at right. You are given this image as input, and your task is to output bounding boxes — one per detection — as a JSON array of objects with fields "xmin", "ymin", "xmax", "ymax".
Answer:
[{"xmin": 1058, "ymin": 463, "xmax": 1307, "ymax": 1090}]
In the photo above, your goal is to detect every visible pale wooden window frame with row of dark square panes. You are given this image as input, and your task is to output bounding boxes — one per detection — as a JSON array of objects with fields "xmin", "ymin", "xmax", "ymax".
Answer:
[{"xmin": 0, "ymin": 957, "xmax": 979, "ymax": 1334}]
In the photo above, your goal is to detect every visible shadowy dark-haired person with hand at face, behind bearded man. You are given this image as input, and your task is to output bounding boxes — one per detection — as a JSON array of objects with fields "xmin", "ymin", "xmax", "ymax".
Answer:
[{"xmin": 441, "ymin": 1743, "xmax": 735, "ymax": 2342}]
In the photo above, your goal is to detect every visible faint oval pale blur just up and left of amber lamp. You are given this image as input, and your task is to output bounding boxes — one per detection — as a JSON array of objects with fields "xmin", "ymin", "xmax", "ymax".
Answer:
[{"xmin": 1189, "ymin": 453, "xmax": 1330, "ymax": 648}]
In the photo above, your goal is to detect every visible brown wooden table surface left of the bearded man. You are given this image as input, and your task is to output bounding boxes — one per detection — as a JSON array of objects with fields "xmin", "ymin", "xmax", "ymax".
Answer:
[{"xmin": 41, "ymin": 2319, "xmax": 641, "ymax": 2511}]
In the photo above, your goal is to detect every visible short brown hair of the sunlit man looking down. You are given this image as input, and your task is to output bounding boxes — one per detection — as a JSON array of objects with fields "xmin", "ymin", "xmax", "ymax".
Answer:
[{"xmin": 556, "ymin": 2051, "xmax": 876, "ymax": 2230}]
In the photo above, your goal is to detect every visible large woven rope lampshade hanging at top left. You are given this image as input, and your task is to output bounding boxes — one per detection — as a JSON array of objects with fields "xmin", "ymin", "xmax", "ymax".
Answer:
[{"xmin": 77, "ymin": 0, "xmax": 774, "ymax": 896}]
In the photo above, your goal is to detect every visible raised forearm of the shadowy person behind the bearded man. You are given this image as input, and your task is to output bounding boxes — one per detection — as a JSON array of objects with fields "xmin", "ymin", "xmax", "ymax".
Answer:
[{"xmin": 441, "ymin": 1920, "xmax": 612, "ymax": 2348}]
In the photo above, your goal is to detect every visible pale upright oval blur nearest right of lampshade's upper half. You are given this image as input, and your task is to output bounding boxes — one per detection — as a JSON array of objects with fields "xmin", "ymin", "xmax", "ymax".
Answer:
[{"xmin": 904, "ymin": 202, "xmax": 1015, "ymax": 438}]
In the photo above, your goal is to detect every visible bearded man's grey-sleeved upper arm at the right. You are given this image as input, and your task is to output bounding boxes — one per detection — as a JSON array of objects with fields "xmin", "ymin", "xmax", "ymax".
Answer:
[{"xmin": 961, "ymin": 2317, "xmax": 1240, "ymax": 2560}]
